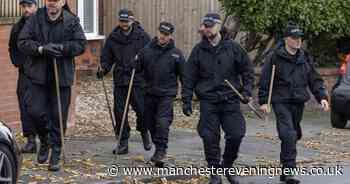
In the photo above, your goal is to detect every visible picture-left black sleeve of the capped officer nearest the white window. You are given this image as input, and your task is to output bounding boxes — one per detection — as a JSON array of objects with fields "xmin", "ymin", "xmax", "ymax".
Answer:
[{"xmin": 100, "ymin": 38, "xmax": 115, "ymax": 73}]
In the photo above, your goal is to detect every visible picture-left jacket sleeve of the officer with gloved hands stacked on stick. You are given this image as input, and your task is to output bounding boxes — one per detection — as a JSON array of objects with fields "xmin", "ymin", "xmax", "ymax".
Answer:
[{"xmin": 17, "ymin": 16, "xmax": 40, "ymax": 56}]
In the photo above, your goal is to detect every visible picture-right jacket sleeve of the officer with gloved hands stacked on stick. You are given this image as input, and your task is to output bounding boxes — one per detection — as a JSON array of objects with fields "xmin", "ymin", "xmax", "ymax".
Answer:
[{"xmin": 63, "ymin": 18, "xmax": 87, "ymax": 57}]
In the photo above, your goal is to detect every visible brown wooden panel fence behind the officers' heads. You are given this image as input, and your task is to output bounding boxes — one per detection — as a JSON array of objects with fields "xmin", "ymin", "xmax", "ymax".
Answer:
[{"xmin": 101, "ymin": 0, "xmax": 221, "ymax": 56}]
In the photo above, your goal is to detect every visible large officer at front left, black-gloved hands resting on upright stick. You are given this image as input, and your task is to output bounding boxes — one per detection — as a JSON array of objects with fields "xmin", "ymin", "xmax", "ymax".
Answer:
[{"xmin": 18, "ymin": 0, "xmax": 87, "ymax": 171}]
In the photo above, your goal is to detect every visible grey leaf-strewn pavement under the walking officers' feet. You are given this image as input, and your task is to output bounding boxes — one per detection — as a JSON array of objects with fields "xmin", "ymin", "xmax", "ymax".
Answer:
[{"xmin": 20, "ymin": 112, "xmax": 350, "ymax": 184}]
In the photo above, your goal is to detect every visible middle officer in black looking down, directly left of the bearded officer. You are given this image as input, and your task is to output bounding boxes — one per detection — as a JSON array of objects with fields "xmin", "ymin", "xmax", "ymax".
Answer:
[{"xmin": 138, "ymin": 22, "xmax": 185, "ymax": 164}]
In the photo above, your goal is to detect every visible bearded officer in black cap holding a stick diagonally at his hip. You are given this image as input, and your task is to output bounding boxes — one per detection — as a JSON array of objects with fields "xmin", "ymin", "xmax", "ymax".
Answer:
[{"xmin": 182, "ymin": 13, "xmax": 254, "ymax": 184}]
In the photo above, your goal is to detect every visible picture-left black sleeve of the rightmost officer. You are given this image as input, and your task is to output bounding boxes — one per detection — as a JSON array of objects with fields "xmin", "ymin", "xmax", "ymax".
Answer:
[{"xmin": 258, "ymin": 53, "xmax": 273, "ymax": 105}]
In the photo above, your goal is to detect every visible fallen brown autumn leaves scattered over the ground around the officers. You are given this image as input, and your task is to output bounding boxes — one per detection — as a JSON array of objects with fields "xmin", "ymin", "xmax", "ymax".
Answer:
[{"xmin": 17, "ymin": 76, "xmax": 350, "ymax": 184}]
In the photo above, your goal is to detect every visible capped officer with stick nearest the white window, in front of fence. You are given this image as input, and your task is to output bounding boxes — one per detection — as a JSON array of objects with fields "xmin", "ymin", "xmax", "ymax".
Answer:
[{"xmin": 97, "ymin": 9, "xmax": 151, "ymax": 154}]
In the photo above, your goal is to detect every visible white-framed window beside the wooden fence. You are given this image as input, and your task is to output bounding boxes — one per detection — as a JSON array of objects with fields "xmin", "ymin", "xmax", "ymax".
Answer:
[{"xmin": 78, "ymin": 0, "xmax": 98, "ymax": 38}]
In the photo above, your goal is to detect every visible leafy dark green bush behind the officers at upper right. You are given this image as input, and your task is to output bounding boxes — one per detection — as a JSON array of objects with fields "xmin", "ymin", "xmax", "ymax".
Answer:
[{"xmin": 220, "ymin": 0, "xmax": 350, "ymax": 66}]
